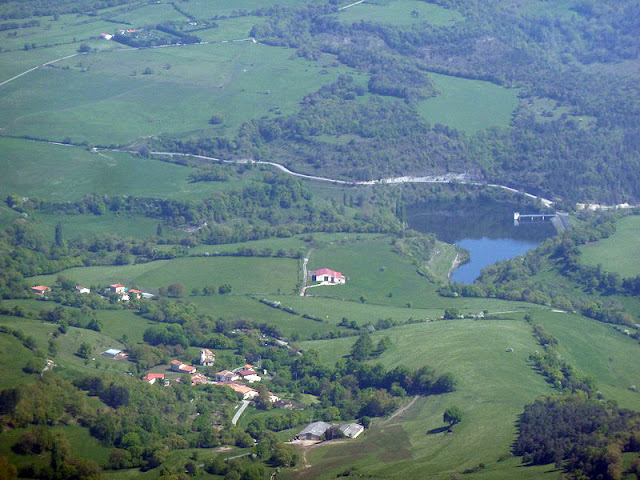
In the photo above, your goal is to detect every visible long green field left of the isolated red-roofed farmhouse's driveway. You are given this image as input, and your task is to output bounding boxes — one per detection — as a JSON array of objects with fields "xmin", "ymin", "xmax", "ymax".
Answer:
[{"xmin": 29, "ymin": 257, "xmax": 298, "ymax": 294}]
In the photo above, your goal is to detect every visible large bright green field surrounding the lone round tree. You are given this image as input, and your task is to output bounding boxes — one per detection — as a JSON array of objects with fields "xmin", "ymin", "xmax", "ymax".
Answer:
[{"xmin": 302, "ymin": 321, "xmax": 558, "ymax": 480}]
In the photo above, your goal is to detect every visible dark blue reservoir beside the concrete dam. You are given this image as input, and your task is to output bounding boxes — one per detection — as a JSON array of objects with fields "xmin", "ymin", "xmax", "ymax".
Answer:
[{"xmin": 407, "ymin": 200, "xmax": 556, "ymax": 283}]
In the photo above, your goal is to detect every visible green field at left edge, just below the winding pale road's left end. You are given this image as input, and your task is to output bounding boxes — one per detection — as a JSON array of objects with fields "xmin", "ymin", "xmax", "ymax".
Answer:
[{"xmin": 0, "ymin": 138, "xmax": 249, "ymax": 201}]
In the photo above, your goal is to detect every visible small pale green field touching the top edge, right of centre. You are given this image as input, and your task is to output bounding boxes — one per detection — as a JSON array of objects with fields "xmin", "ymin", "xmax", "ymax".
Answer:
[{"xmin": 338, "ymin": 0, "xmax": 463, "ymax": 26}]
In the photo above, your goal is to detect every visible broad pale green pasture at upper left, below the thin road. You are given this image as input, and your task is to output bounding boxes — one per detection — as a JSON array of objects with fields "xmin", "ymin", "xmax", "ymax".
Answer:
[{"xmin": 0, "ymin": 42, "xmax": 362, "ymax": 145}]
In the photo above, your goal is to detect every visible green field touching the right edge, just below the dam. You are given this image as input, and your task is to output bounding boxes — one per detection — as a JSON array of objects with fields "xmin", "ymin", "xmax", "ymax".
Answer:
[{"xmin": 580, "ymin": 215, "xmax": 640, "ymax": 277}]
